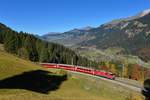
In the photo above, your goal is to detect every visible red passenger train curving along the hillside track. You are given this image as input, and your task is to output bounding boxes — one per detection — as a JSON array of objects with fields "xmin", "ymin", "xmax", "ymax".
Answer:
[{"xmin": 40, "ymin": 63, "xmax": 115, "ymax": 80}]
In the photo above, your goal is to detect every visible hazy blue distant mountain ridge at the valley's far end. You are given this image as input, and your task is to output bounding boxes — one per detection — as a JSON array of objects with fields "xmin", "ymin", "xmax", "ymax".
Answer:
[{"xmin": 41, "ymin": 26, "xmax": 93, "ymax": 46}]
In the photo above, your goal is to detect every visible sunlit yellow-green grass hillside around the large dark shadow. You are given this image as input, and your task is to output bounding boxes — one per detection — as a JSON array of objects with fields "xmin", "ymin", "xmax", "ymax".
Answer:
[{"xmin": 0, "ymin": 48, "xmax": 142, "ymax": 100}]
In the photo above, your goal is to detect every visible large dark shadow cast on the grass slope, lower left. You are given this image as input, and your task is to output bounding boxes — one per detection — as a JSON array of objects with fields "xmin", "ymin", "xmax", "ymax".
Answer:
[{"xmin": 0, "ymin": 70, "xmax": 67, "ymax": 94}]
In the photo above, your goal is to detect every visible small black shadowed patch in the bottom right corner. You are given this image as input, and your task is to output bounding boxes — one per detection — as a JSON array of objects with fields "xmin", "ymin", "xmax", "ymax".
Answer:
[{"xmin": 142, "ymin": 79, "xmax": 150, "ymax": 100}]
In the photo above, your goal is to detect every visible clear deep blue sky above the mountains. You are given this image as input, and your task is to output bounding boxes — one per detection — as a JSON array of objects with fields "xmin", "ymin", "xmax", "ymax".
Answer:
[{"xmin": 0, "ymin": 0, "xmax": 150, "ymax": 35}]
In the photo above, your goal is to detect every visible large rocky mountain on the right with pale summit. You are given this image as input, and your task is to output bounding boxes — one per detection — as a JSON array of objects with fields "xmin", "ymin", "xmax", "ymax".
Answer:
[{"xmin": 78, "ymin": 10, "xmax": 150, "ymax": 61}]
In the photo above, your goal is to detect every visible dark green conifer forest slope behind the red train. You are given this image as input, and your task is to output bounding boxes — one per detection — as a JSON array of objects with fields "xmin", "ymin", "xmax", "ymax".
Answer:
[{"xmin": 0, "ymin": 24, "xmax": 96, "ymax": 66}]
